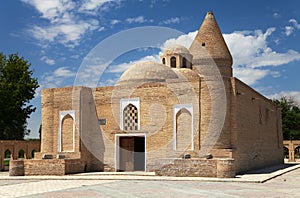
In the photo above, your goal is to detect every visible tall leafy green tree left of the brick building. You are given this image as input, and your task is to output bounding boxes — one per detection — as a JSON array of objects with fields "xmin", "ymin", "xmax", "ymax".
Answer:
[{"xmin": 0, "ymin": 52, "xmax": 39, "ymax": 140}]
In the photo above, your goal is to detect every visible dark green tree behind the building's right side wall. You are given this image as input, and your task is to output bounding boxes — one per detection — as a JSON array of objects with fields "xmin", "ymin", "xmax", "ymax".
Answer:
[{"xmin": 273, "ymin": 97, "xmax": 300, "ymax": 140}]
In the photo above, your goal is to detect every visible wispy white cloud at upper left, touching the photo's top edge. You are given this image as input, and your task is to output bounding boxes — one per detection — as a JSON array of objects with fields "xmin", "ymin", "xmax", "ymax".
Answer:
[{"xmin": 22, "ymin": 0, "xmax": 120, "ymax": 48}]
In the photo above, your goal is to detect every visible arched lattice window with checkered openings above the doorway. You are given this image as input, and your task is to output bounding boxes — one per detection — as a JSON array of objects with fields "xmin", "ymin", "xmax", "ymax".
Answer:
[{"xmin": 123, "ymin": 104, "xmax": 138, "ymax": 131}]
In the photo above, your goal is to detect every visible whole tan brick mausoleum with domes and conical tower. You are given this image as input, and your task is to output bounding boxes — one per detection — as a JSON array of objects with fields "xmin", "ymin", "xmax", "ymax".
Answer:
[{"xmin": 24, "ymin": 12, "xmax": 283, "ymax": 177}]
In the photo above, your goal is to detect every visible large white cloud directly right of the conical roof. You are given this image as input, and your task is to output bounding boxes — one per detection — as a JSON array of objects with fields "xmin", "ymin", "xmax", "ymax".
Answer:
[{"xmin": 224, "ymin": 28, "xmax": 300, "ymax": 85}]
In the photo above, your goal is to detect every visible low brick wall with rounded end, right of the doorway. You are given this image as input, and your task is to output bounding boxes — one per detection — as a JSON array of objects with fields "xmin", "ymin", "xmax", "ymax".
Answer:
[{"xmin": 155, "ymin": 158, "xmax": 235, "ymax": 178}]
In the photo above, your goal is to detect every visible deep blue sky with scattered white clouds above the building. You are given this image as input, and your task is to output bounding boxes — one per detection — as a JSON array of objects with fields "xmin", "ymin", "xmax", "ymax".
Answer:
[{"xmin": 0, "ymin": 0, "xmax": 300, "ymax": 137}]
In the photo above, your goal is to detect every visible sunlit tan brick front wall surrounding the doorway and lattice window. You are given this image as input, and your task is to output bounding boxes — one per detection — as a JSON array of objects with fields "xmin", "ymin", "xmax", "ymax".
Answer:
[{"xmin": 94, "ymin": 72, "xmax": 199, "ymax": 170}]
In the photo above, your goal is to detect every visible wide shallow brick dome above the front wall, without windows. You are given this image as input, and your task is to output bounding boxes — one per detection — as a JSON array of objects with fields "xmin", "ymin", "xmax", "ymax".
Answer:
[{"xmin": 120, "ymin": 62, "xmax": 178, "ymax": 82}]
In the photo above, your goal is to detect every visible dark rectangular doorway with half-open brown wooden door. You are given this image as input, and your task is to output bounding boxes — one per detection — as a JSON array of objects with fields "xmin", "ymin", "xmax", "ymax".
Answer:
[{"xmin": 118, "ymin": 136, "xmax": 145, "ymax": 172}]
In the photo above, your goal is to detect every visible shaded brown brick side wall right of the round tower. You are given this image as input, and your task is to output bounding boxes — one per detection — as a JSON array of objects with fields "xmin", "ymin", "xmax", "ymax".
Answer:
[{"xmin": 232, "ymin": 78, "xmax": 283, "ymax": 172}]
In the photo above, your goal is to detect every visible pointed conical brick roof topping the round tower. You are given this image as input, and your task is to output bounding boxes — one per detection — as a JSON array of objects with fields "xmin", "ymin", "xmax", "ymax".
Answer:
[{"xmin": 190, "ymin": 12, "xmax": 232, "ymax": 72}]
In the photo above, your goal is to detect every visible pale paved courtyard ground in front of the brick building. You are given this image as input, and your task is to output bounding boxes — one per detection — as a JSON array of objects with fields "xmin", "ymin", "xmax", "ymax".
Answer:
[{"xmin": 0, "ymin": 168, "xmax": 300, "ymax": 198}]
